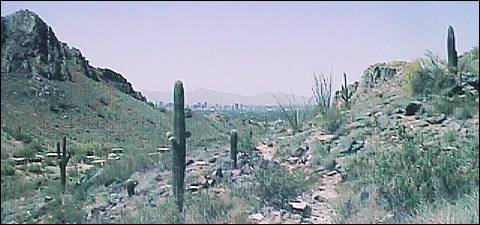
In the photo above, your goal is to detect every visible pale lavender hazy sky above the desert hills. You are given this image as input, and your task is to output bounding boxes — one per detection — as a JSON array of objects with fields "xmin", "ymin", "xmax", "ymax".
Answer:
[{"xmin": 1, "ymin": 1, "xmax": 479, "ymax": 96}]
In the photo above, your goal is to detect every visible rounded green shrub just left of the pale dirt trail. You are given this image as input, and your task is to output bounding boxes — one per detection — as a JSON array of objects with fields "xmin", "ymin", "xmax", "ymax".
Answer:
[{"xmin": 254, "ymin": 161, "xmax": 312, "ymax": 208}]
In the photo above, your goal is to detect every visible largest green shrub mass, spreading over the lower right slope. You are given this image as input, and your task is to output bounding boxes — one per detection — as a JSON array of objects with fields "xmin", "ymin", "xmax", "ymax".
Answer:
[{"xmin": 348, "ymin": 127, "xmax": 479, "ymax": 212}]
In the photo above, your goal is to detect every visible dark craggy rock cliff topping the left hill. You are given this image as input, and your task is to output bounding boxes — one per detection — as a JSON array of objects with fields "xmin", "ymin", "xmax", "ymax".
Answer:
[{"xmin": 1, "ymin": 10, "xmax": 146, "ymax": 101}]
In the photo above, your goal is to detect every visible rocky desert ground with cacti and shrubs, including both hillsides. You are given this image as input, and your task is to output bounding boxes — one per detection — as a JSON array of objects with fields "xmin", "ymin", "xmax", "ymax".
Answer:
[{"xmin": 1, "ymin": 7, "xmax": 480, "ymax": 224}]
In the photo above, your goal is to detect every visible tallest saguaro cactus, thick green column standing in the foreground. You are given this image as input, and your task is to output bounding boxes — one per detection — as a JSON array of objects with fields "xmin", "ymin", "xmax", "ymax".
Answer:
[{"xmin": 169, "ymin": 81, "xmax": 187, "ymax": 212}]
